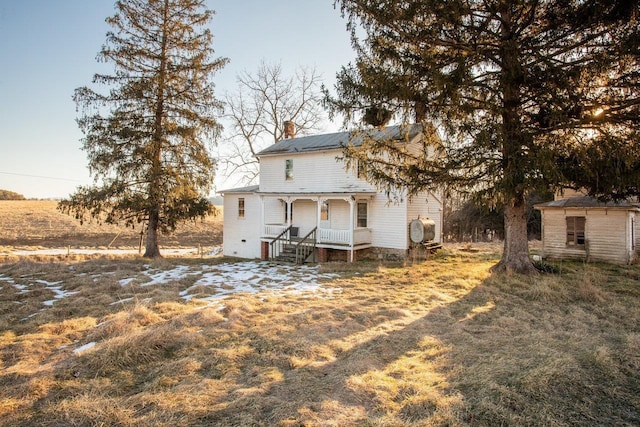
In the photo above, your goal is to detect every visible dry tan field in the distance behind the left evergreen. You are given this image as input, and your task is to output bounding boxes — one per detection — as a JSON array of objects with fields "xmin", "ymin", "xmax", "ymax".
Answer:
[{"xmin": 0, "ymin": 200, "xmax": 222, "ymax": 252}]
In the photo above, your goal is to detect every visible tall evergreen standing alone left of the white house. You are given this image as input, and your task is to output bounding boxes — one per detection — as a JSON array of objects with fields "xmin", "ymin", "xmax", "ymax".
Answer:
[{"xmin": 59, "ymin": 0, "xmax": 227, "ymax": 257}]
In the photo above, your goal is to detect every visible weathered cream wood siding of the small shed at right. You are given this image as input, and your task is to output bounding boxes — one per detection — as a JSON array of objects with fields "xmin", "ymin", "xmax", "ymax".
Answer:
[{"xmin": 543, "ymin": 208, "xmax": 630, "ymax": 263}]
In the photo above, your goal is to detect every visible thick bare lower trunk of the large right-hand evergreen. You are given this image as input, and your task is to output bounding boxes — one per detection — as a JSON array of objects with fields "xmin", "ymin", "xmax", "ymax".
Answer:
[{"xmin": 491, "ymin": 202, "xmax": 538, "ymax": 274}]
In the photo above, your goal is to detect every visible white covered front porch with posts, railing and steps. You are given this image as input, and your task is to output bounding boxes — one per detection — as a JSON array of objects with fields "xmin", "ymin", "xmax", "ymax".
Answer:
[{"xmin": 260, "ymin": 193, "xmax": 375, "ymax": 262}]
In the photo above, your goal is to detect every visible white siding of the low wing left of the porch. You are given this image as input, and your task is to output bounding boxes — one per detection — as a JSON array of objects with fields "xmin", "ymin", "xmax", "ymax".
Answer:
[{"xmin": 222, "ymin": 193, "xmax": 262, "ymax": 258}]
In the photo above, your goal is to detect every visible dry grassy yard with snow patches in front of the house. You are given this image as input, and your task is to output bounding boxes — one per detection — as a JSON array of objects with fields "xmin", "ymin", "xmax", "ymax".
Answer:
[{"xmin": 0, "ymin": 249, "xmax": 640, "ymax": 426}]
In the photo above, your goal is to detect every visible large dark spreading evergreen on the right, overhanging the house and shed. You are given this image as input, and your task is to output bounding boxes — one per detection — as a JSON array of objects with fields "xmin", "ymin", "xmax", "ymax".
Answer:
[{"xmin": 327, "ymin": 0, "xmax": 640, "ymax": 273}]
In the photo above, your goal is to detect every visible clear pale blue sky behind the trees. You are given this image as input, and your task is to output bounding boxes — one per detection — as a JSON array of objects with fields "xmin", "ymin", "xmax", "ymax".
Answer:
[{"xmin": 0, "ymin": 0, "xmax": 354, "ymax": 198}]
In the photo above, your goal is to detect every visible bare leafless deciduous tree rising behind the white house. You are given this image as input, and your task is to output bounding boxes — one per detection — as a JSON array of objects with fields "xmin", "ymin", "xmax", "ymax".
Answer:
[{"xmin": 220, "ymin": 62, "xmax": 324, "ymax": 184}]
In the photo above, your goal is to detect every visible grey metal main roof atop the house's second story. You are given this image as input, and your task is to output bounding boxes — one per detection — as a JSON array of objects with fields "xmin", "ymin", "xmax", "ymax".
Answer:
[{"xmin": 258, "ymin": 125, "xmax": 422, "ymax": 156}]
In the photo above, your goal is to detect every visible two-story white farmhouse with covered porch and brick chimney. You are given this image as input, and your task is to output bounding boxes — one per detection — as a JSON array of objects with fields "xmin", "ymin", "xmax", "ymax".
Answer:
[{"xmin": 222, "ymin": 125, "xmax": 443, "ymax": 262}]
